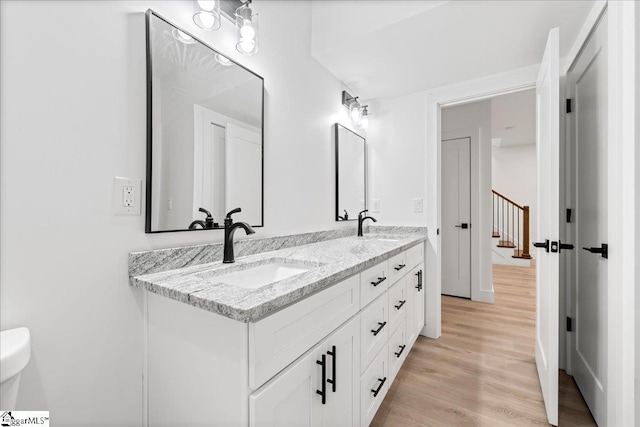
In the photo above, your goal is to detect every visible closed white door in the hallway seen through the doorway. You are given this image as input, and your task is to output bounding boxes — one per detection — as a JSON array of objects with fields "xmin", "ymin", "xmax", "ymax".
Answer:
[{"xmin": 442, "ymin": 138, "xmax": 471, "ymax": 298}]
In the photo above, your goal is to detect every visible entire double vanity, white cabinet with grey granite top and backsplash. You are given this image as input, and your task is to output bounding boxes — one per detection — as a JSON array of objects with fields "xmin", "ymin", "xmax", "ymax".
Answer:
[{"xmin": 129, "ymin": 227, "xmax": 426, "ymax": 426}]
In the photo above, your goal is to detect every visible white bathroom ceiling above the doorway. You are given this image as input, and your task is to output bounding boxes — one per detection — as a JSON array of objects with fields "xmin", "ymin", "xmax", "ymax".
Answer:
[{"xmin": 312, "ymin": 0, "xmax": 593, "ymax": 99}]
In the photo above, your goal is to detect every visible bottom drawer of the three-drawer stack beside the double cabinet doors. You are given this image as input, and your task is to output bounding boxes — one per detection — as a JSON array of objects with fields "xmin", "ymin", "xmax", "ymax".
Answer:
[{"xmin": 360, "ymin": 344, "xmax": 391, "ymax": 426}]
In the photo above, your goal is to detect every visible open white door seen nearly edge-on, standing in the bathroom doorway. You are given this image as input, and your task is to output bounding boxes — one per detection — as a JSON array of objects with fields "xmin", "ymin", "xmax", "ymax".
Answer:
[{"xmin": 535, "ymin": 28, "xmax": 560, "ymax": 425}]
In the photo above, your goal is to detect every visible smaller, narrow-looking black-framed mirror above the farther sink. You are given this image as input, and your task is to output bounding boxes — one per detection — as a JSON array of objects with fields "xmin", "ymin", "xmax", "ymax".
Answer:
[{"xmin": 334, "ymin": 123, "xmax": 367, "ymax": 221}]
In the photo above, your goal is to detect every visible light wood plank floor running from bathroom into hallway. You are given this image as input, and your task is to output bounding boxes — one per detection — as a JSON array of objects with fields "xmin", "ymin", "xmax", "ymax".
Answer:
[{"xmin": 371, "ymin": 263, "xmax": 596, "ymax": 427}]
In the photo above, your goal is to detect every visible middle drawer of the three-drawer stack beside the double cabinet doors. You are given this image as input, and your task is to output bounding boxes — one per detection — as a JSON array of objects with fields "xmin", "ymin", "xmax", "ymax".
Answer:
[{"xmin": 360, "ymin": 292, "xmax": 389, "ymax": 372}]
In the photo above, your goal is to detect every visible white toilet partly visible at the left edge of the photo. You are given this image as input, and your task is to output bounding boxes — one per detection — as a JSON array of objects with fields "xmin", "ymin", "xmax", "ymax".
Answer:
[{"xmin": 0, "ymin": 328, "xmax": 31, "ymax": 411}]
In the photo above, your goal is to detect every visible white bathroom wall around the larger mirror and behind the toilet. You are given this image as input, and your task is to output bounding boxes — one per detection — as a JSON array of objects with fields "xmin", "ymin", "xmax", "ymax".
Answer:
[{"xmin": 0, "ymin": 1, "xmax": 358, "ymax": 426}]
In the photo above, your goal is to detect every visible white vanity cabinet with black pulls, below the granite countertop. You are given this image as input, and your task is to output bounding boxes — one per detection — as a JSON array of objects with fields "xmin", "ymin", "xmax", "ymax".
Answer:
[{"xmin": 144, "ymin": 243, "xmax": 424, "ymax": 427}]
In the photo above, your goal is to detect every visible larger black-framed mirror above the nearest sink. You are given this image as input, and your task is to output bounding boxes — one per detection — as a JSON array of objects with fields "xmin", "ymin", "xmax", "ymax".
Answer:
[{"xmin": 145, "ymin": 11, "xmax": 264, "ymax": 233}]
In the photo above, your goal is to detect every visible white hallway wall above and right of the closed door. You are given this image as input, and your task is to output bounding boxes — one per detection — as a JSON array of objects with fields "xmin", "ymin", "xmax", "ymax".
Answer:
[{"xmin": 441, "ymin": 100, "xmax": 493, "ymax": 302}]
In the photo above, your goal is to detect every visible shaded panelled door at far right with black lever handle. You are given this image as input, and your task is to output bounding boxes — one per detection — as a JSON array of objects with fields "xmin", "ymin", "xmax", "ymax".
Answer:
[{"xmin": 568, "ymin": 14, "xmax": 607, "ymax": 425}]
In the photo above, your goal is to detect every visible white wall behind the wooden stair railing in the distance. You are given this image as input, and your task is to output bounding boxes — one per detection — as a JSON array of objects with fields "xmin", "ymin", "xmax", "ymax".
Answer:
[{"xmin": 491, "ymin": 144, "xmax": 538, "ymax": 246}]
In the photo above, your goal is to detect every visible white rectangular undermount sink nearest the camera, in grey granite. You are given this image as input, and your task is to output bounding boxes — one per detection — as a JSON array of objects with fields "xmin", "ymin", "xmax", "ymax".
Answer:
[{"xmin": 210, "ymin": 262, "xmax": 312, "ymax": 289}]
